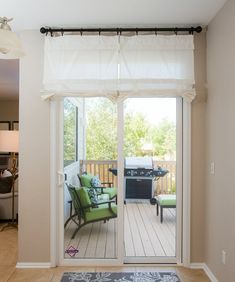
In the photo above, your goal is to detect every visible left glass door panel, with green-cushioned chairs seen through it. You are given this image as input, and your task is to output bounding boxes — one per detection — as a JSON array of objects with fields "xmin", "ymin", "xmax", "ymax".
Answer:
[{"xmin": 64, "ymin": 98, "xmax": 117, "ymax": 260}]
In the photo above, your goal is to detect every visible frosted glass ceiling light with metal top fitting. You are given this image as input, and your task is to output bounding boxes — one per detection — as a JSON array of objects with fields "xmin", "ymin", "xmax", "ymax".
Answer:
[{"xmin": 0, "ymin": 17, "xmax": 24, "ymax": 59}]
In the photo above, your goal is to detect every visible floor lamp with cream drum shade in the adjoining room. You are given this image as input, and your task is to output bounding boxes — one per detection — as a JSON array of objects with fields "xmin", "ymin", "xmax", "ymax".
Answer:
[{"xmin": 0, "ymin": 130, "xmax": 19, "ymax": 231}]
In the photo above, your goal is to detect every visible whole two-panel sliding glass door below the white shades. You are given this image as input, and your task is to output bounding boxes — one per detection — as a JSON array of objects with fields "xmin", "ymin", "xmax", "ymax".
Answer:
[{"xmin": 59, "ymin": 97, "xmax": 182, "ymax": 265}]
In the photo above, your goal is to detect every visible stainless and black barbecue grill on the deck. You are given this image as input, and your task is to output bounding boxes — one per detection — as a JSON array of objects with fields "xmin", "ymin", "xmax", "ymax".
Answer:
[{"xmin": 109, "ymin": 157, "xmax": 168, "ymax": 200}]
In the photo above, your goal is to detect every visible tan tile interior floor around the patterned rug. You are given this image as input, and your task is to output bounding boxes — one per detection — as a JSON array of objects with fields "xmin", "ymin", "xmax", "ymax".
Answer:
[{"xmin": 0, "ymin": 229, "xmax": 210, "ymax": 282}]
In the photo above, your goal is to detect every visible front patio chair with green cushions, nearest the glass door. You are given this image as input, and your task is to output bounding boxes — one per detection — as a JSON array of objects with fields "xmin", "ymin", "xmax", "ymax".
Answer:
[{"xmin": 66, "ymin": 184, "xmax": 117, "ymax": 239}]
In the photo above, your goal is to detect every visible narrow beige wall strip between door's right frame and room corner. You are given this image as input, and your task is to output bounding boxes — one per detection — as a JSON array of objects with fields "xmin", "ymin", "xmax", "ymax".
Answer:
[{"xmin": 191, "ymin": 32, "xmax": 207, "ymax": 262}]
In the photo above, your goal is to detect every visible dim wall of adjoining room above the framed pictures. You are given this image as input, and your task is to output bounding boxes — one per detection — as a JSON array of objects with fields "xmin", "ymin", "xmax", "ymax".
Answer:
[{"xmin": 0, "ymin": 100, "xmax": 19, "ymax": 121}]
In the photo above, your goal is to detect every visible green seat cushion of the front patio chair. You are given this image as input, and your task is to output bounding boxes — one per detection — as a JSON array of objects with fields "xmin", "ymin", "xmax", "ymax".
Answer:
[{"xmin": 86, "ymin": 204, "xmax": 117, "ymax": 221}]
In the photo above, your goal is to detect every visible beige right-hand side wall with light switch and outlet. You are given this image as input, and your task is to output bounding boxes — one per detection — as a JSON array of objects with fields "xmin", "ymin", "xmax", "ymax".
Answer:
[{"xmin": 205, "ymin": 0, "xmax": 235, "ymax": 282}]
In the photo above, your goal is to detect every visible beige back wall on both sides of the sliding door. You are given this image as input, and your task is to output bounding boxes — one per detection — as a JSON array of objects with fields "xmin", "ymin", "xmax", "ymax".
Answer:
[{"xmin": 19, "ymin": 31, "xmax": 205, "ymax": 263}]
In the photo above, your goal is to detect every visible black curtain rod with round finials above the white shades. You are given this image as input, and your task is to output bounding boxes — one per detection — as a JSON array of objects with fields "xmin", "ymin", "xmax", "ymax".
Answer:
[{"xmin": 40, "ymin": 26, "xmax": 202, "ymax": 36}]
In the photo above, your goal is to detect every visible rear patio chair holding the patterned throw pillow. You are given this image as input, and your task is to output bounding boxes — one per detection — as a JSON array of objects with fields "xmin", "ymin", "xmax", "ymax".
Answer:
[{"xmin": 78, "ymin": 172, "xmax": 117, "ymax": 204}]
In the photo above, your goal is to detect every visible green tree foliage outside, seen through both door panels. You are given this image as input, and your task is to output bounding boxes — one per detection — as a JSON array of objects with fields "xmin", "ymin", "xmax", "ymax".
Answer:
[{"xmin": 86, "ymin": 98, "xmax": 176, "ymax": 160}]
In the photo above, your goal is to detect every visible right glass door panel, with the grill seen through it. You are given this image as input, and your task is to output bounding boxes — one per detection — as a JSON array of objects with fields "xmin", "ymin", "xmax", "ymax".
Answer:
[{"xmin": 124, "ymin": 98, "xmax": 177, "ymax": 262}]
